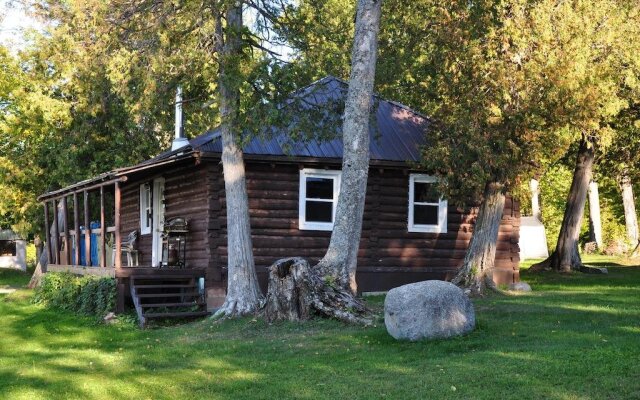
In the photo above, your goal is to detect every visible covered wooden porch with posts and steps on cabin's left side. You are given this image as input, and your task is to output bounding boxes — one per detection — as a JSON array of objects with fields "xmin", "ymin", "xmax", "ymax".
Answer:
[{"xmin": 39, "ymin": 176, "xmax": 218, "ymax": 324}]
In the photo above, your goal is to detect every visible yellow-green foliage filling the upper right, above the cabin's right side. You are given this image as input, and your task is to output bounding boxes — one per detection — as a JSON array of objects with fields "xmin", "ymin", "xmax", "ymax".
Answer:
[{"xmin": 290, "ymin": 0, "xmax": 640, "ymax": 206}]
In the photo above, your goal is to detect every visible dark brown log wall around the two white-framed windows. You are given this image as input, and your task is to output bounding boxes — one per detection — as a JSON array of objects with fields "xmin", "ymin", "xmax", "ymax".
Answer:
[{"xmin": 215, "ymin": 163, "xmax": 520, "ymax": 291}]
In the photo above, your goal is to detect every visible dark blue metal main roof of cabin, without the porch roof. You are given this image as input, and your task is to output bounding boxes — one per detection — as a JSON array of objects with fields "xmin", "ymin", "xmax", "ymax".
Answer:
[{"xmin": 190, "ymin": 76, "xmax": 430, "ymax": 162}]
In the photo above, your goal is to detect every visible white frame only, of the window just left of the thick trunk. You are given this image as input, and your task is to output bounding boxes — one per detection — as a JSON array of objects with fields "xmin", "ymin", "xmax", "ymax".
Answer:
[{"xmin": 298, "ymin": 168, "xmax": 342, "ymax": 231}]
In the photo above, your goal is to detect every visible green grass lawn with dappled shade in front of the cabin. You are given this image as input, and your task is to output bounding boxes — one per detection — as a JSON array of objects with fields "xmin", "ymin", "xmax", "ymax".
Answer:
[{"xmin": 0, "ymin": 257, "xmax": 640, "ymax": 399}]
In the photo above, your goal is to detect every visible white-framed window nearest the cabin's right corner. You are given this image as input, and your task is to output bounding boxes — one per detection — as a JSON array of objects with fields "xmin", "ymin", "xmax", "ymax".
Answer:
[{"xmin": 409, "ymin": 174, "xmax": 447, "ymax": 233}]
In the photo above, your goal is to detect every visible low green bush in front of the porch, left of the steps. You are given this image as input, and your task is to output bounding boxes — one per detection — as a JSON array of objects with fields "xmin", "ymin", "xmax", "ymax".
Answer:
[{"xmin": 33, "ymin": 272, "xmax": 116, "ymax": 318}]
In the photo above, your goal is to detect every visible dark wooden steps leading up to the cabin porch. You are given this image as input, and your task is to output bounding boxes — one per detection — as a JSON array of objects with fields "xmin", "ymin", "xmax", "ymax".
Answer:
[{"xmin": 129, "ymin": 274, "xmax": 210, "ymax": 328}]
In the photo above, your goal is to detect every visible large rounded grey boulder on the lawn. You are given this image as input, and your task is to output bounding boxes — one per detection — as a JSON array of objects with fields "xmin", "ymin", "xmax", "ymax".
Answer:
[{"xmin": 384, "ymin": 281, "xmax": 476, "ymax": 341}]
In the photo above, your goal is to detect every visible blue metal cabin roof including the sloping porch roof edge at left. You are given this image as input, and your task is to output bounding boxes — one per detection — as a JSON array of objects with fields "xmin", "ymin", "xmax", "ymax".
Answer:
[{"xmin": 38, "ymin": 76, "xmax": 430, "ymax": 201}]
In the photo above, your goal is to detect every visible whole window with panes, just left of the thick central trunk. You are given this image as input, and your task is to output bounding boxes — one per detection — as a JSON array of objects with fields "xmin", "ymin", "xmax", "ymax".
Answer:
[{"xmin": 299, "ymin": 169, "xmax": 341, "ymax": 231}]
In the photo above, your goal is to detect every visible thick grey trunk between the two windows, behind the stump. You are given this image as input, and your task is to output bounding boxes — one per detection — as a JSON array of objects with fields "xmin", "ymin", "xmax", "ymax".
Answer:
[{"xmin": 316, "ymin": 0, "xmax": 382, "ymax": 294}]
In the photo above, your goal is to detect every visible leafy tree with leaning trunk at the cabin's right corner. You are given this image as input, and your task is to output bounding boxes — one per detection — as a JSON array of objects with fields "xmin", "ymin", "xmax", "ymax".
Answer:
[{"xmin": 410, "ymin": 1, "xmax": 568, "ymax": 294}]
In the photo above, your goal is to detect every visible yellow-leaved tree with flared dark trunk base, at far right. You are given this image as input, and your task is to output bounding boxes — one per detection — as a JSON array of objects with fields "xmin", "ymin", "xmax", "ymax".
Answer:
[{"xmin": 532, "ymin": 0, "xmax": 640, "ymax": 272}]
